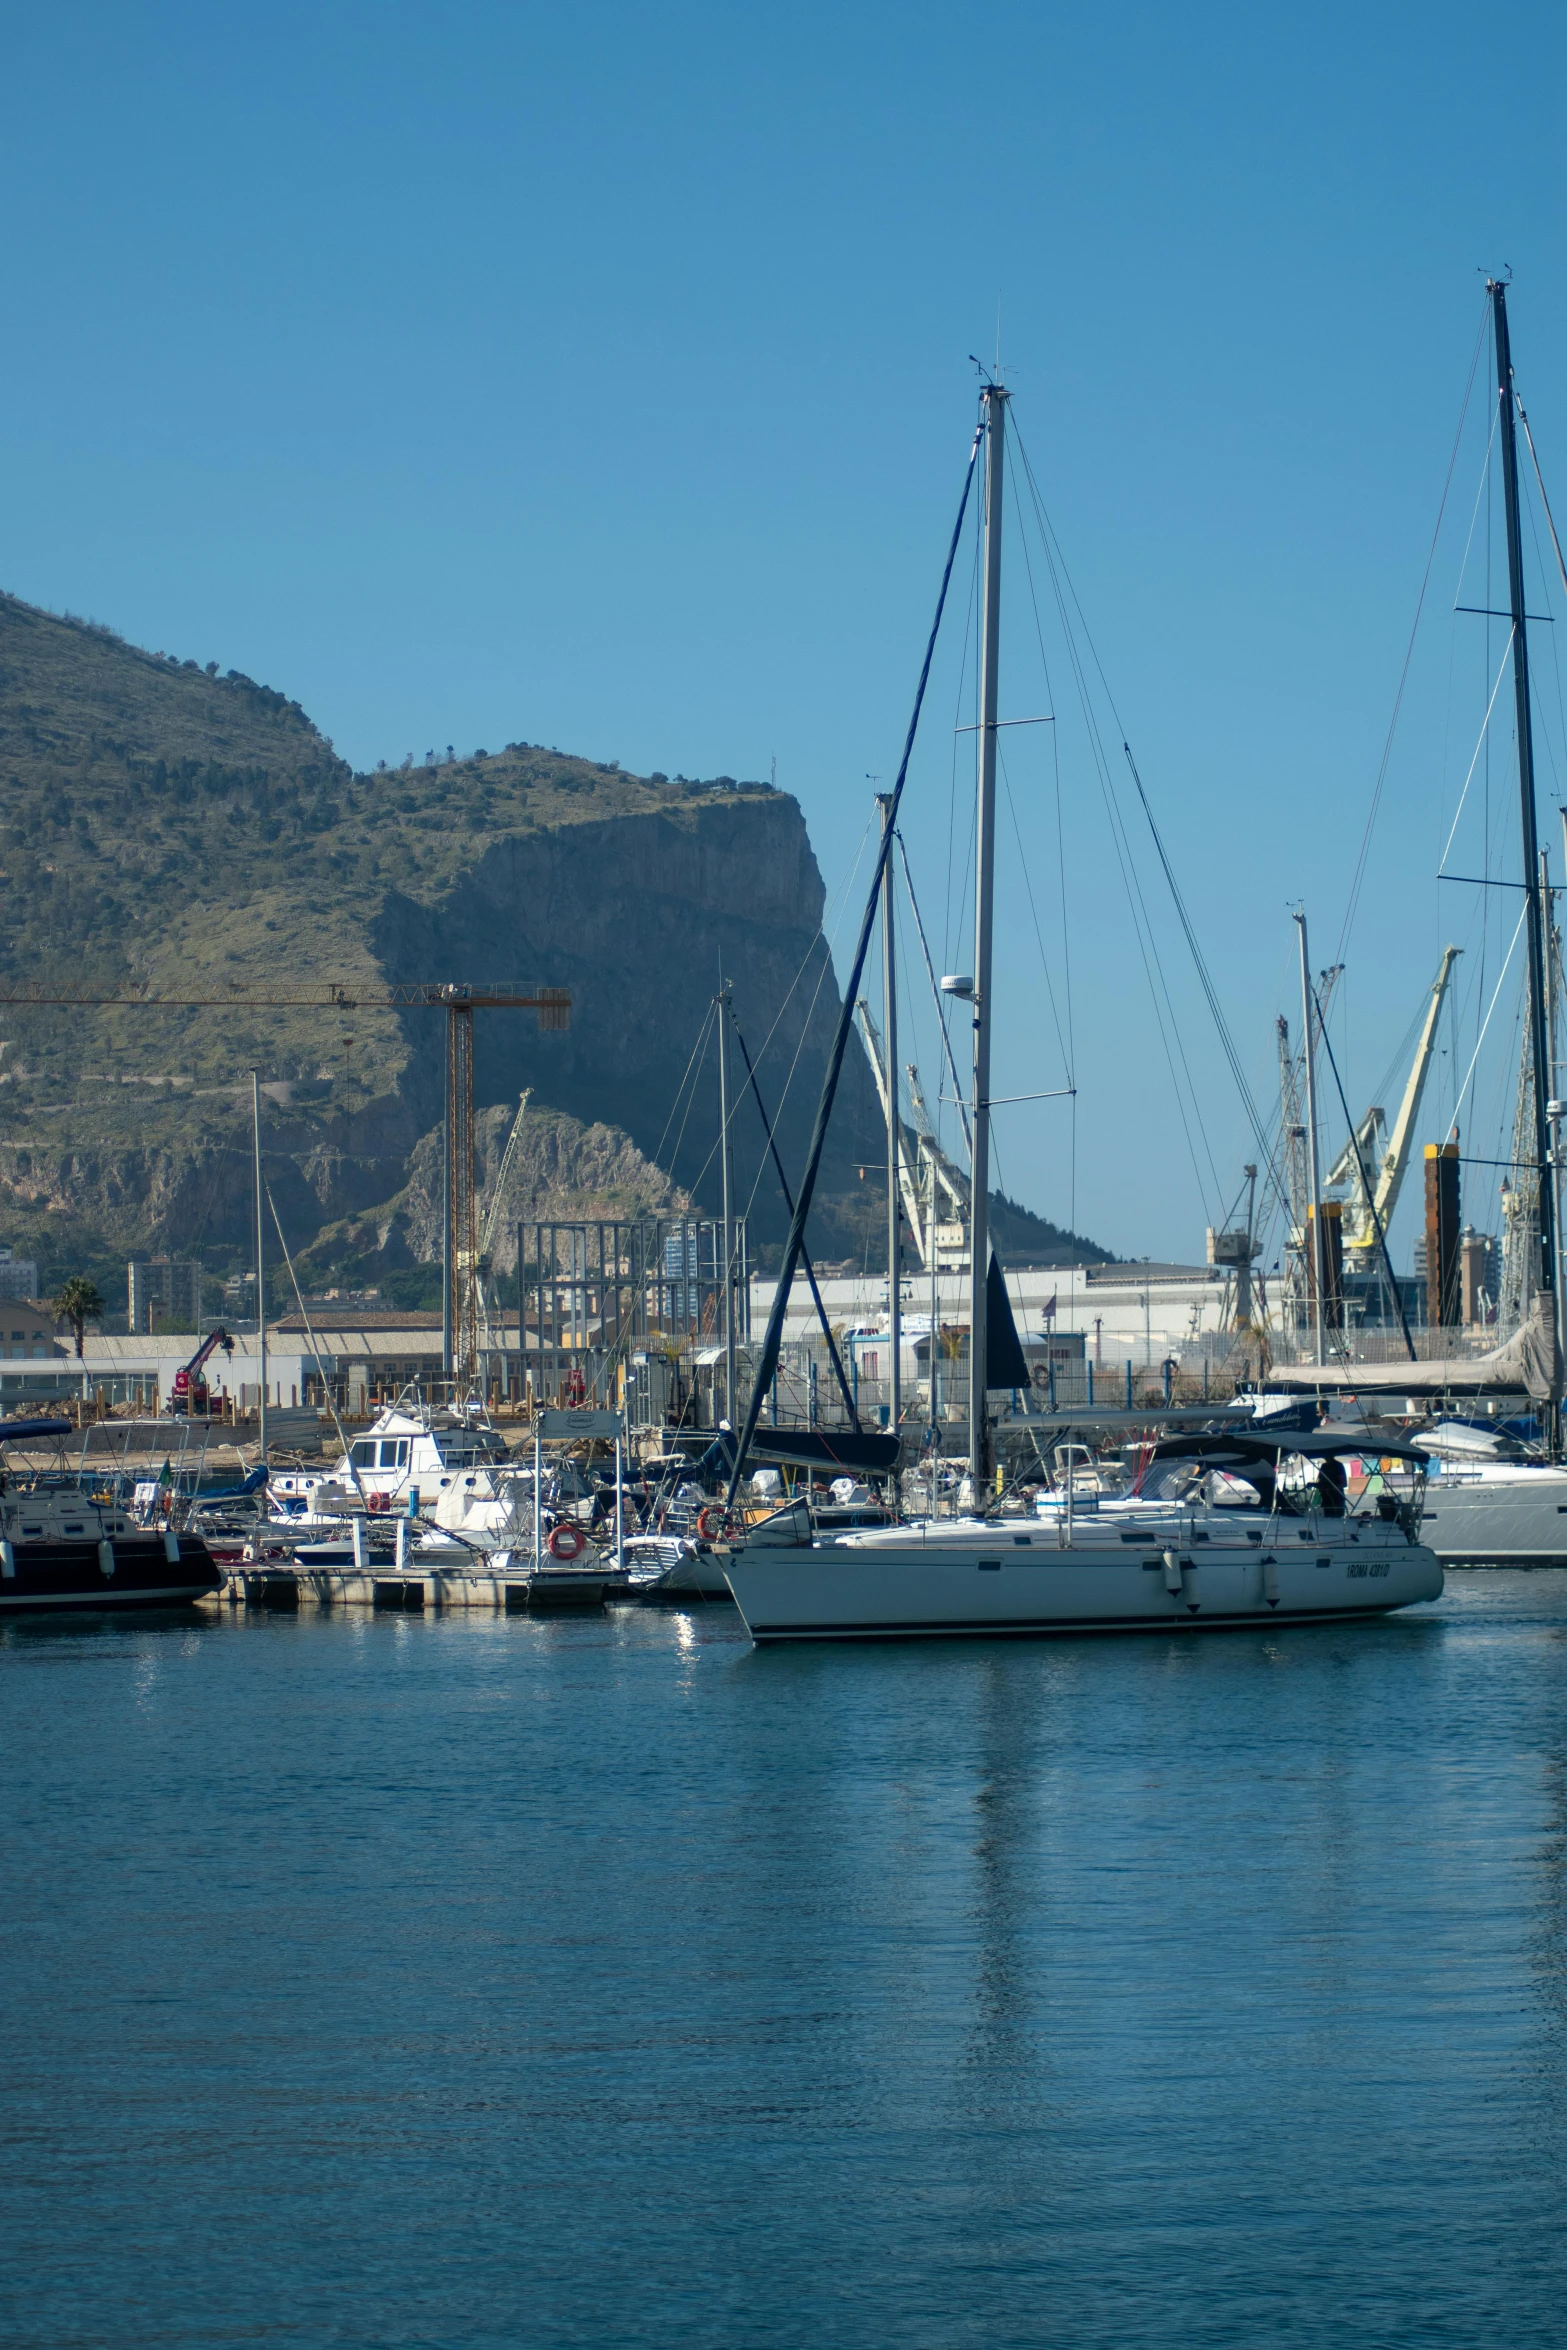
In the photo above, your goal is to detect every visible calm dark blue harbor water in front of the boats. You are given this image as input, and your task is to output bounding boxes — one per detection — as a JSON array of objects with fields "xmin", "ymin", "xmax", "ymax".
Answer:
[{"xmin": 0, "ymin": 1575, "xmax": 1567, "ymax": 2350}]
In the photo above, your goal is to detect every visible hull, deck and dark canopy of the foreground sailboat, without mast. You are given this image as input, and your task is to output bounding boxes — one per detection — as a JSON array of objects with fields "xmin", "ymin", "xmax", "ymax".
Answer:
[{"xmin": 724, "ymin": 1431, "xmax": 1442, "ymax": 1645}]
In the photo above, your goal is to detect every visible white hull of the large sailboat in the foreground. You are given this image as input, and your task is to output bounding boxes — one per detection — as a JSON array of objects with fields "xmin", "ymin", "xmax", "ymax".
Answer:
[{"xmin": 726, "ymin": 1523, "xmax": 1442, "ymax": 1645}]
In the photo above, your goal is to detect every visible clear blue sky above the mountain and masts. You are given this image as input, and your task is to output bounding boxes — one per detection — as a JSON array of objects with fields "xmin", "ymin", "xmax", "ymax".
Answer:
[{"xmin": 0, "ymin": 0, "xmax": 1567, "ymax": 1255}]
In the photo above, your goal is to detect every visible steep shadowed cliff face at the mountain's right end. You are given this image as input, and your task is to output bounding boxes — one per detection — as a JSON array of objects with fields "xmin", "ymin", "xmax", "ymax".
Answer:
[{"xmin": 371, "ymin": 792, "xmax": 876, "ymax": 1203}]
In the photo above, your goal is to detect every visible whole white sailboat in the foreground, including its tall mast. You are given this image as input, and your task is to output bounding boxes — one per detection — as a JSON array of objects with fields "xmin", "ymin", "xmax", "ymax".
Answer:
[{"xmin": 721, "ymin": 383, "xmax": 1442, "ymax": 1645}]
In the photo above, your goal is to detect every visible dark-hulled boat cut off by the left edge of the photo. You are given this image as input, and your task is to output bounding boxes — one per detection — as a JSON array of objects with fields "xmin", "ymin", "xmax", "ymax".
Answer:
[{"xmin": 0, "ymin": 1419, "xmax": 221, "ymax": 1617}]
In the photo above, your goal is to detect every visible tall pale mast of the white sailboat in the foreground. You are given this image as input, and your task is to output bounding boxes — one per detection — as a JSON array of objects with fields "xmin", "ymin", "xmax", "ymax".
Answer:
[{"xmin": 968, "ymin": 383, "xmax": 1008, "ymax": 1502}]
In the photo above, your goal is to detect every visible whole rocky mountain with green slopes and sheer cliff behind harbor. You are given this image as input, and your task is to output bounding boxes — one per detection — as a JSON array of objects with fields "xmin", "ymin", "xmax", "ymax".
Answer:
[{"xmin": 0, "ymin": 597, "xmax": 879, "ymax": 1271}]
